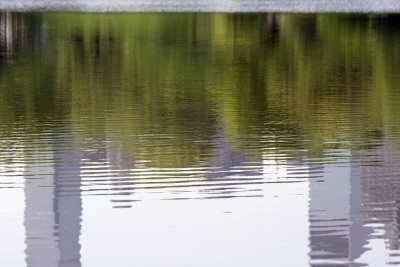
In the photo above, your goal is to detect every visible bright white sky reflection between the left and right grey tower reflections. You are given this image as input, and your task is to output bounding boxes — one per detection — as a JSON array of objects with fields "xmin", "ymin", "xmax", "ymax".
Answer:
[{"xmin": 81, "ymin": 183, "xmax": 309, "ymax": 267}]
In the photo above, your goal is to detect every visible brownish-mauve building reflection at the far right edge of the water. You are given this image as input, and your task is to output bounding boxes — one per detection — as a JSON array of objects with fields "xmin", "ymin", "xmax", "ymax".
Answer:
[{"xmin": 361, "ymin": 142, "xmax": 400, "ymax": 253}]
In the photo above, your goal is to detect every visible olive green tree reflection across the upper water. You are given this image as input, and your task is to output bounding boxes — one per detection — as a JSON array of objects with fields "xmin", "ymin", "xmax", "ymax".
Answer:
[{"xmin": 0, "ymin": 13, "xmax": 400, "ymax": 167}]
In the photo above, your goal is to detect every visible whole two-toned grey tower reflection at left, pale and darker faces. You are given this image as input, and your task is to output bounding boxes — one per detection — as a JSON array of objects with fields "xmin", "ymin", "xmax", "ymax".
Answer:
[{"xmin": 24, "ymin": 136, "xmax": 82, "ymax": 267}]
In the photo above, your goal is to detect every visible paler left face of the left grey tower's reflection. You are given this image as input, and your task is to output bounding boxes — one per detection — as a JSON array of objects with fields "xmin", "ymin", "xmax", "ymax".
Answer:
[{"xmin": 24, "ymin": 148, "xmax": 60, "ymax": 266}]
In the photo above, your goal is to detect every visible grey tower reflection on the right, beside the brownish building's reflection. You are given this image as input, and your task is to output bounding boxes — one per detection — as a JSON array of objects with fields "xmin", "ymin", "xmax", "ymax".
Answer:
[{"xmin": 309, "ymin": 150, "xmax": 369, "ymax": 266}]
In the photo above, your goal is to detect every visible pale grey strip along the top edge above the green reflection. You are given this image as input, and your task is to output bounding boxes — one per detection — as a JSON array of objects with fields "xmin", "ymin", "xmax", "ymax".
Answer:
[{"xmin": 0, "ymin": 0, "xmax": 400, "ymax": 13}]
